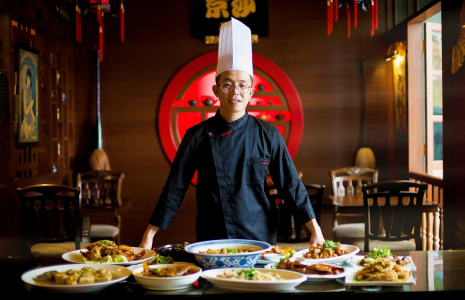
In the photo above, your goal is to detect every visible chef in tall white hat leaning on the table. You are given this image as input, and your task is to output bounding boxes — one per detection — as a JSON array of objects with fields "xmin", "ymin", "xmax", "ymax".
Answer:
[{"xmin": 140, "ymin": 18, "xmax": 325, "ymax": 249}]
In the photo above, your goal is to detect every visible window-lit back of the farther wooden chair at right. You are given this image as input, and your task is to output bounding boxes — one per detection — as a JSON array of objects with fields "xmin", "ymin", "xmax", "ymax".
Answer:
[{"xmin": 329, "ymin": 167, "xmax": 379, "ymax": 196}]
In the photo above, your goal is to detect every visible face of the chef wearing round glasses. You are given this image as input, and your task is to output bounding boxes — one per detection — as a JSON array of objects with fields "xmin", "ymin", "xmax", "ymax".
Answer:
[{"xmin": 212, "ymin": 70, "xmax": 253, "ymax": 121}]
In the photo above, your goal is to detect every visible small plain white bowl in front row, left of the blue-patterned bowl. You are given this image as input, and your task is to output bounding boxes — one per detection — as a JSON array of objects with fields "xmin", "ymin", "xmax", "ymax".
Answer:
[{"xmin": 132, "ymin": 264, "xmax": 202, "ymax": 291}]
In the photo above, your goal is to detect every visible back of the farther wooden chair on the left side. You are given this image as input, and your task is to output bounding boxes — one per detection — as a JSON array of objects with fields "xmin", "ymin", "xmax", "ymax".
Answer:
[{"xmin": 76, "ymin": 171, "xmax": 125, "ymax": 206}]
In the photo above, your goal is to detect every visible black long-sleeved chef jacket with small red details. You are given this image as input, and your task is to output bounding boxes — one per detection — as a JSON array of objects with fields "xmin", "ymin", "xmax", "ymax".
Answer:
[{"xmin": 150, "ymin": 110, "xmax": 315, "ymax": 245}]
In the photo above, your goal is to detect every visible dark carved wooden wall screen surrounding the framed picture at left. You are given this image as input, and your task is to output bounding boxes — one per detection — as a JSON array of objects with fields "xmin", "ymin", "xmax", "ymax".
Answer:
[{"xmin": 0, "ymin": 18, "xmax": 74, "ymax": 184}]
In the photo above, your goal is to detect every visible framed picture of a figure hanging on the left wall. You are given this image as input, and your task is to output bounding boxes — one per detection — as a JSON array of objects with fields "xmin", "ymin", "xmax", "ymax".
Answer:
[{"xmin": 16, "ymin": 44, "xmax": 40, "ymax": 147}]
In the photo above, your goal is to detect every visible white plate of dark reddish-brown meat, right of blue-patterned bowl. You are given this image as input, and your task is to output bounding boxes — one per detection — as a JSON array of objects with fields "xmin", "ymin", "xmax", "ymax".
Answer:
[{"xmin": 265, "ymin": 260, "xmax": 347, "ymax": 281}]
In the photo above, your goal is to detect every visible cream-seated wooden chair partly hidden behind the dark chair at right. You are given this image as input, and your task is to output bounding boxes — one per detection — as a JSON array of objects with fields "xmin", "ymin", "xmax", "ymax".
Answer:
[{"xmin": 329, "ymin": 167, "xmax": 379, "ymax": 243}]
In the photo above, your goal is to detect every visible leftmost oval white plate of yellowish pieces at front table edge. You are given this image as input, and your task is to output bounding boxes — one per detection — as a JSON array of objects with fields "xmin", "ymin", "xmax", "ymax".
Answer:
[{"xmin": 21, "ymin": 264, "xmax": 131, "ymax": 293}]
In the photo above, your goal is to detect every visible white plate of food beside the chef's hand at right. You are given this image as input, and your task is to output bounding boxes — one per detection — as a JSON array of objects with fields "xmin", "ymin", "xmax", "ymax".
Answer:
[{"xmin": 293, "ymin": 240, "xmax": 360, "ymax": 264}]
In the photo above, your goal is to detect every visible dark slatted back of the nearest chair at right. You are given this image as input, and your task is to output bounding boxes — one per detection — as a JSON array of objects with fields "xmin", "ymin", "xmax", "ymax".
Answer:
[{"xmin": 362, "ymin": 180, "xmax": 428, "ymax": 252}]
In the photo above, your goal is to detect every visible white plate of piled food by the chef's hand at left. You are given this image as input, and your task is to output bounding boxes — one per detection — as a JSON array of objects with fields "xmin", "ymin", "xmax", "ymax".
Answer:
[{"xmin": 62, "ymin": 240, "xmax": 156, "ymax": 265}]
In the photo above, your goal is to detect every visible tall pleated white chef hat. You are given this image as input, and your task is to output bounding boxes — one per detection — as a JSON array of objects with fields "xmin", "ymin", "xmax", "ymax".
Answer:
[{"xmin": 216, "ymin": 18, "xmax": 253, "ymax": 78}]
